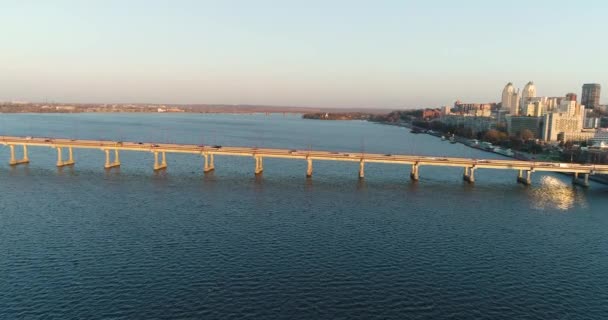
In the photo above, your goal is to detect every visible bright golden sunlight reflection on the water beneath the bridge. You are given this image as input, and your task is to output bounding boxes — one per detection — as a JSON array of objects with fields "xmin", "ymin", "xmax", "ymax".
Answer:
[{"xmin": 530, "ymin": 176, "xmax": 586, "ymax": 211}]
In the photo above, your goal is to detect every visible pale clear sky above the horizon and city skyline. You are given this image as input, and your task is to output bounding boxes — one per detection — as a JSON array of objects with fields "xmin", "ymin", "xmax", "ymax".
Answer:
[{"xmin": 0, "ymin": 0, "xmax": 608, "ymax": 108}]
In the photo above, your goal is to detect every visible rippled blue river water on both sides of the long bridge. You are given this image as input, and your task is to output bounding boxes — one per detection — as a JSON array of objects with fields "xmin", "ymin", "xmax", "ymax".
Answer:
[{"xmin": 0, "ymin": 114, "xmax": 608, "ymax": 319}]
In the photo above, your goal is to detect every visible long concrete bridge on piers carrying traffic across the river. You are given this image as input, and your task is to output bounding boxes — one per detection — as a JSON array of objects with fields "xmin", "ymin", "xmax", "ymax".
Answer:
[{"xmin": 0, "ymin": 136, "xmax": 608, "ymax": 187}]
